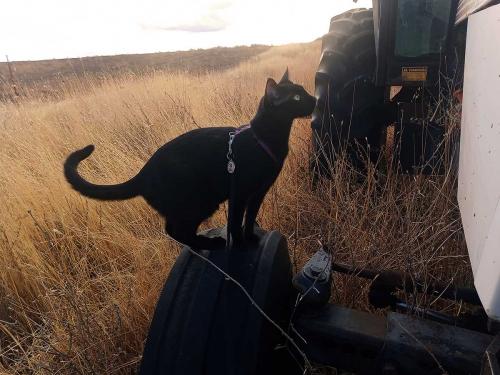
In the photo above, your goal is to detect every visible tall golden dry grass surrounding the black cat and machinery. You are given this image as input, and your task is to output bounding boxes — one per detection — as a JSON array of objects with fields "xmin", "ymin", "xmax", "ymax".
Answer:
[{"xmin": 0, "ymin": 42, "xmax": 471, "ymax": 374}]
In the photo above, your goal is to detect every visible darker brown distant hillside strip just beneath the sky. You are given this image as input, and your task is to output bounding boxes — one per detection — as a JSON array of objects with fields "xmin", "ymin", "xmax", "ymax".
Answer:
[{"xmin": 0, "ymin": 45, "xmax": 269, "ymax": 101}]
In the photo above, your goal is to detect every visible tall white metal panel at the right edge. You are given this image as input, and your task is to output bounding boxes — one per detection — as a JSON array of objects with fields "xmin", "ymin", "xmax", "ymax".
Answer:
[{"xmin": 458, "ymin": 5, "xmax": 500, "ymax": 320}]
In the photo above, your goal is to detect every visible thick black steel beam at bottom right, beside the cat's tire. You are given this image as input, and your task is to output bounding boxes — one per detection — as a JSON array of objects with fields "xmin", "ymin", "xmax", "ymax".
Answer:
[{"xmin": 294, "ymin": 305, "xmax": 493, "ymax": 375}]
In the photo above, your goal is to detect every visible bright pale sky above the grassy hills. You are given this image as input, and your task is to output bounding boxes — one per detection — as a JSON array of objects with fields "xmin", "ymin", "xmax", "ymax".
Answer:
[{"xmin": 0, "ymin": 0, "xmax": 371, "ymax": 60}]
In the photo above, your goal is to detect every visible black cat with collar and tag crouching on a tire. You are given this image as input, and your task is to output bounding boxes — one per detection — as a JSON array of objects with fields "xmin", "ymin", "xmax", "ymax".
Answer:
[{"xmin": 64, "ymin": 70, "xmax": 316, "ymax": 249}]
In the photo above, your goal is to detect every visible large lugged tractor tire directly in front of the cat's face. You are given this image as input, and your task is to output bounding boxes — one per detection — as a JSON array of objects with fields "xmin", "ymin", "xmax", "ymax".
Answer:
[{"xmin": 311, "ymin": 9, "xmax": 391, "ymax": 177}]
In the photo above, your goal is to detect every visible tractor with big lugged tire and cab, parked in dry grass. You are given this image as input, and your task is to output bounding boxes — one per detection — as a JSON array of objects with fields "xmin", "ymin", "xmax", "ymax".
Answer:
[{"xmin": 311, "ymin": 0, "xmax": 498, "ymax": 177}]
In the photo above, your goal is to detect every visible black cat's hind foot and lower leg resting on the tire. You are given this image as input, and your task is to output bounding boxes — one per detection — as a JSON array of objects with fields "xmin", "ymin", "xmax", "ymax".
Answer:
[{"xmin": 165, "ymin": 220, "xmax": 226, "ymax": 251}]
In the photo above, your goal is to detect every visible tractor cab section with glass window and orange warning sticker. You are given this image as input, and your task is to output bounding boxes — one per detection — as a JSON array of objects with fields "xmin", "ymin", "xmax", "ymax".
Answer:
[{"xmin": 373, "ymin": 0, "xmax": 457, "ymax": 86}]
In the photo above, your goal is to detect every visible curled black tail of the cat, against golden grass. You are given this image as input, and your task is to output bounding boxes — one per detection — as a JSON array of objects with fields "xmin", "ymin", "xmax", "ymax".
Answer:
[{"xmin": 64, "ymin": 145, "xmax": 141, "ymax": 200}]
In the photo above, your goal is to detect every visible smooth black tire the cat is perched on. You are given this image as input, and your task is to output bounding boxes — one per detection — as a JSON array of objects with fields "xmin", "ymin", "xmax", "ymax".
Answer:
[{"xmin": 140, "ymin": 230, "xmax": 300, "ymax": 375}]
